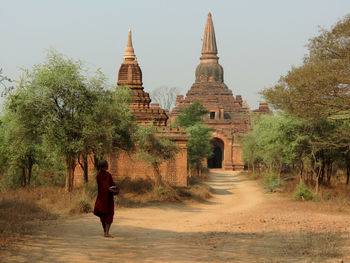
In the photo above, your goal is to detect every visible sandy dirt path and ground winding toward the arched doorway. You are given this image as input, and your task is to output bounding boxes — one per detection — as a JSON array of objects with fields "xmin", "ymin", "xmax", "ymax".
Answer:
[{"xmin": 0, "ymin": 171, "xmax": 350, "ymax": 263}]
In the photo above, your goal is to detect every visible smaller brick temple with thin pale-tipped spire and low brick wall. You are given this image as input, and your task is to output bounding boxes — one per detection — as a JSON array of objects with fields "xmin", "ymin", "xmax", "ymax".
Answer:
[{"xmin": 75, "ymin": 30, "xmax": 188, "ymax": 186}]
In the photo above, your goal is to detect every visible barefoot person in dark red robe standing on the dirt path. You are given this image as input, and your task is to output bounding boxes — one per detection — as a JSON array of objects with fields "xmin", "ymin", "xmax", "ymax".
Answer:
[{"xmin": 94, "ymin": 160, "xmax": 119, "ymax": 237}]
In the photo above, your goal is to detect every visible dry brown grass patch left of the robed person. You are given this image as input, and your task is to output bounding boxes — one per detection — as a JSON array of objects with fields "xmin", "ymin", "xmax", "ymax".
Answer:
[{"xmin": 0, "ymin": 186, "xmax": 100, "ymax": 250}]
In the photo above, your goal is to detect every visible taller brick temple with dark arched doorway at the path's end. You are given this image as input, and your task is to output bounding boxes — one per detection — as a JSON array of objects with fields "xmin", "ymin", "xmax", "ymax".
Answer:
[{"xmin": 170, "ymin": 13, "xmax": 270, "ymax": 170}]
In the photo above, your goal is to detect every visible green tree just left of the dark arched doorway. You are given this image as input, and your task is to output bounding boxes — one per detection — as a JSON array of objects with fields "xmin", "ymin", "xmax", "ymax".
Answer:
[{"xmin": 174, "ymin": 101, "xmax": 213, "ymax": 174}]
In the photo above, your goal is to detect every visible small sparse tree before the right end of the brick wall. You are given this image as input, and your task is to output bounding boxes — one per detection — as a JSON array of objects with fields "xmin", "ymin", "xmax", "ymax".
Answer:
[{"xmin": 137, "ymin": 126, "xmax": 179, "ymax": 186}]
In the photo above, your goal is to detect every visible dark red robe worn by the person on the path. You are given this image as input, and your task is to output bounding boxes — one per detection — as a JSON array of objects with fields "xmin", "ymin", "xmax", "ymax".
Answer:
[{"xmin": 94, "ymin": 170, "xmax": 115, "ymax": 224}]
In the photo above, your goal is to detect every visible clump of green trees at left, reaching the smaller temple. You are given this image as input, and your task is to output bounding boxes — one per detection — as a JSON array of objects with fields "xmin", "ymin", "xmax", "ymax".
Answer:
[{"xmin": 0, "ymin": 50, "xmax": 136, "ymax": 191}]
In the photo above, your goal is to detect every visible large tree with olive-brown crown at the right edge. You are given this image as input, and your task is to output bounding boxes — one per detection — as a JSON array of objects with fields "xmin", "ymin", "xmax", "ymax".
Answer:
[{"xmin": 262, "ymin": 15, "xmax": 350, "ymax": 194}]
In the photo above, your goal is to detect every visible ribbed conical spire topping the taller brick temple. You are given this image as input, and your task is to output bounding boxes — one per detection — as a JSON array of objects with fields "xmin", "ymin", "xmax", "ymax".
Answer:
[{"xmin": 201, "ymin": 13, "xmax": 218, "ymax": 62}]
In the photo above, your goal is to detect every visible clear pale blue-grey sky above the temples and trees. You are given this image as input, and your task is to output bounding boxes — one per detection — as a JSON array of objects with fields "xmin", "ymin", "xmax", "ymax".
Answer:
[{"xmin": 0, "ymin": 0, "xmax": 350, "ymax": 108}]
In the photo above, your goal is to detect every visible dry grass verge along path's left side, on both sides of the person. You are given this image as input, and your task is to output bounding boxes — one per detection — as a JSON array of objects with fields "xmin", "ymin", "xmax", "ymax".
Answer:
[{"xmin": 0, "ymin": 176, "xmax": 211, "ymax": 248}]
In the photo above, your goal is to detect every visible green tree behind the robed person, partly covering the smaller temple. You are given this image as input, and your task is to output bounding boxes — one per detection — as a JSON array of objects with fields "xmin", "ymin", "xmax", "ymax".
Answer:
[{"xmin": 78, "ymin": 85, "xmax": 137, "ymax": 182}]
